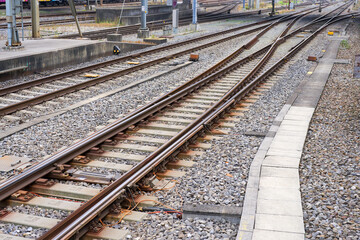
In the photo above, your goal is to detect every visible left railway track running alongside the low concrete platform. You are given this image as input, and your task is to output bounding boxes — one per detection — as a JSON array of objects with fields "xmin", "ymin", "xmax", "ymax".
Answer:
[{"xmin": 0, "ymin": 13, "xmax": 300, "ymax": 118}]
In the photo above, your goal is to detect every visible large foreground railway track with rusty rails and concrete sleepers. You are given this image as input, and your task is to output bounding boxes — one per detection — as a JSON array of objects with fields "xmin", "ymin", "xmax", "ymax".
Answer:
[{"xmin": 0, "ymin": 2, "xmax": 351, "ymax": 239}]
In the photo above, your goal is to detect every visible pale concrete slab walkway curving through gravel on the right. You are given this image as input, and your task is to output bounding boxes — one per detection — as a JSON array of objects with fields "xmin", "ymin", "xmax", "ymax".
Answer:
[{"xmin": 238, "ymin": 31, "xmax": 340, "ymax": 240}]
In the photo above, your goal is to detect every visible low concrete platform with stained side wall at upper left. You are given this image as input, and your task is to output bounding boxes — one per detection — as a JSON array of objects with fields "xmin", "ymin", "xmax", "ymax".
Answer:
[{"xmin": 0, "ymin": 39, "xmax": 152, "ymax": 77}]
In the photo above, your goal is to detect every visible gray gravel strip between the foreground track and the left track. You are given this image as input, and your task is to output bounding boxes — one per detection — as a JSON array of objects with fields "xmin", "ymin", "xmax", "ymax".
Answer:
[{"xmin": 0, "ymin": 23, "xmax": 280, "ymax": 170}]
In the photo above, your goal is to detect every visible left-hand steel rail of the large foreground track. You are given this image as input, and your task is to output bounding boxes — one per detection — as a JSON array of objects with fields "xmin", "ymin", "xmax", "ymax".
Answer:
[{"xmin": 0, "ymin": 7, "xmax": 314, "ymax": 200}]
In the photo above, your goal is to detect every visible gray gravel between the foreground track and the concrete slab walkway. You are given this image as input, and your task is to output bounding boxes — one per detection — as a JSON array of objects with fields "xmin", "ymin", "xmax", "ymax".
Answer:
[{"xmin": 117, "ymin": 26, "xmax": 327, "ymax": 239}]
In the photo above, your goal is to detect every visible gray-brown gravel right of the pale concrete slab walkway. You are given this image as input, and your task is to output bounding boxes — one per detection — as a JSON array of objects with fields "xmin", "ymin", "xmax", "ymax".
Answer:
[{"xmin": 300, "ymin": 20, "xmax": 360, "ymax": 240}]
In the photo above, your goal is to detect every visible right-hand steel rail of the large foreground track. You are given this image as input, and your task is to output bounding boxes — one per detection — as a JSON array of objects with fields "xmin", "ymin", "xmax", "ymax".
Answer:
[{"xmin": 36, "ymin": 7, "xmax": 340, "ymax": 239}]
